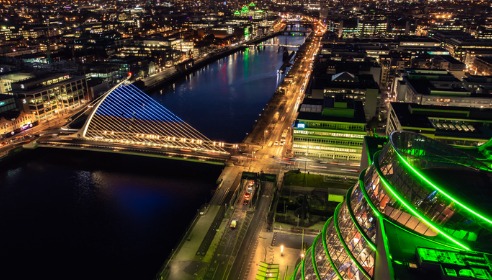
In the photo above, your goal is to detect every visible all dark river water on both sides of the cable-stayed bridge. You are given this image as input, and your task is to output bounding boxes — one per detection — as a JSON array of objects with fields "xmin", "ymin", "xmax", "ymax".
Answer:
[{"xmin": 0, "ymin": 36, "xmax": 304, "ymax": 280}]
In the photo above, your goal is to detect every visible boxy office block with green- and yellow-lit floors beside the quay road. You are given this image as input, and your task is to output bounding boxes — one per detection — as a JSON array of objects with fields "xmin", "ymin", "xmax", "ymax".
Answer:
[{"xmin": 292, "ymin": 97, "xmax": 367, "ymax": 163}]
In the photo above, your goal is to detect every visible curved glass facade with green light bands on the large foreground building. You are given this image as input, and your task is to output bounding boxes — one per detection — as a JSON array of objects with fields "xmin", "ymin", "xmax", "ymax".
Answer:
[{"xmin": 293, "ymin": 131, "xmax": 492, "ymax": 279}]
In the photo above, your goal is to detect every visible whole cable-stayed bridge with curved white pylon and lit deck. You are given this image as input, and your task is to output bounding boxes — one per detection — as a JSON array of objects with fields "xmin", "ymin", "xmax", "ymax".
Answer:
[{"xmin": 38, "ymin": 81, "xmax": 239, "ymax": 163}]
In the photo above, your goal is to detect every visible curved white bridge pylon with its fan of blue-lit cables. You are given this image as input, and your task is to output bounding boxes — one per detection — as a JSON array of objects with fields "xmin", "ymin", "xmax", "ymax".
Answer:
[{"xmin": 81, "ymin": 83, "xmax": 228, "ymax": 154}]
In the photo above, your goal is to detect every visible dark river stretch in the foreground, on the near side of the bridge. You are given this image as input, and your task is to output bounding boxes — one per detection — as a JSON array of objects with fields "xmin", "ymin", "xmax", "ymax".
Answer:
[{"xmin": 0, "ymin": 150, "xmax": 220, "ymax": 279}]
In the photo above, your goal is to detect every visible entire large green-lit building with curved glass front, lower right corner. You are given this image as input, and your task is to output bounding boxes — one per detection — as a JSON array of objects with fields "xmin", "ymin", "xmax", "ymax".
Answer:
[{"xmin": 292, "ymin": 131, "xmax": 492, "ymax": 280}]
